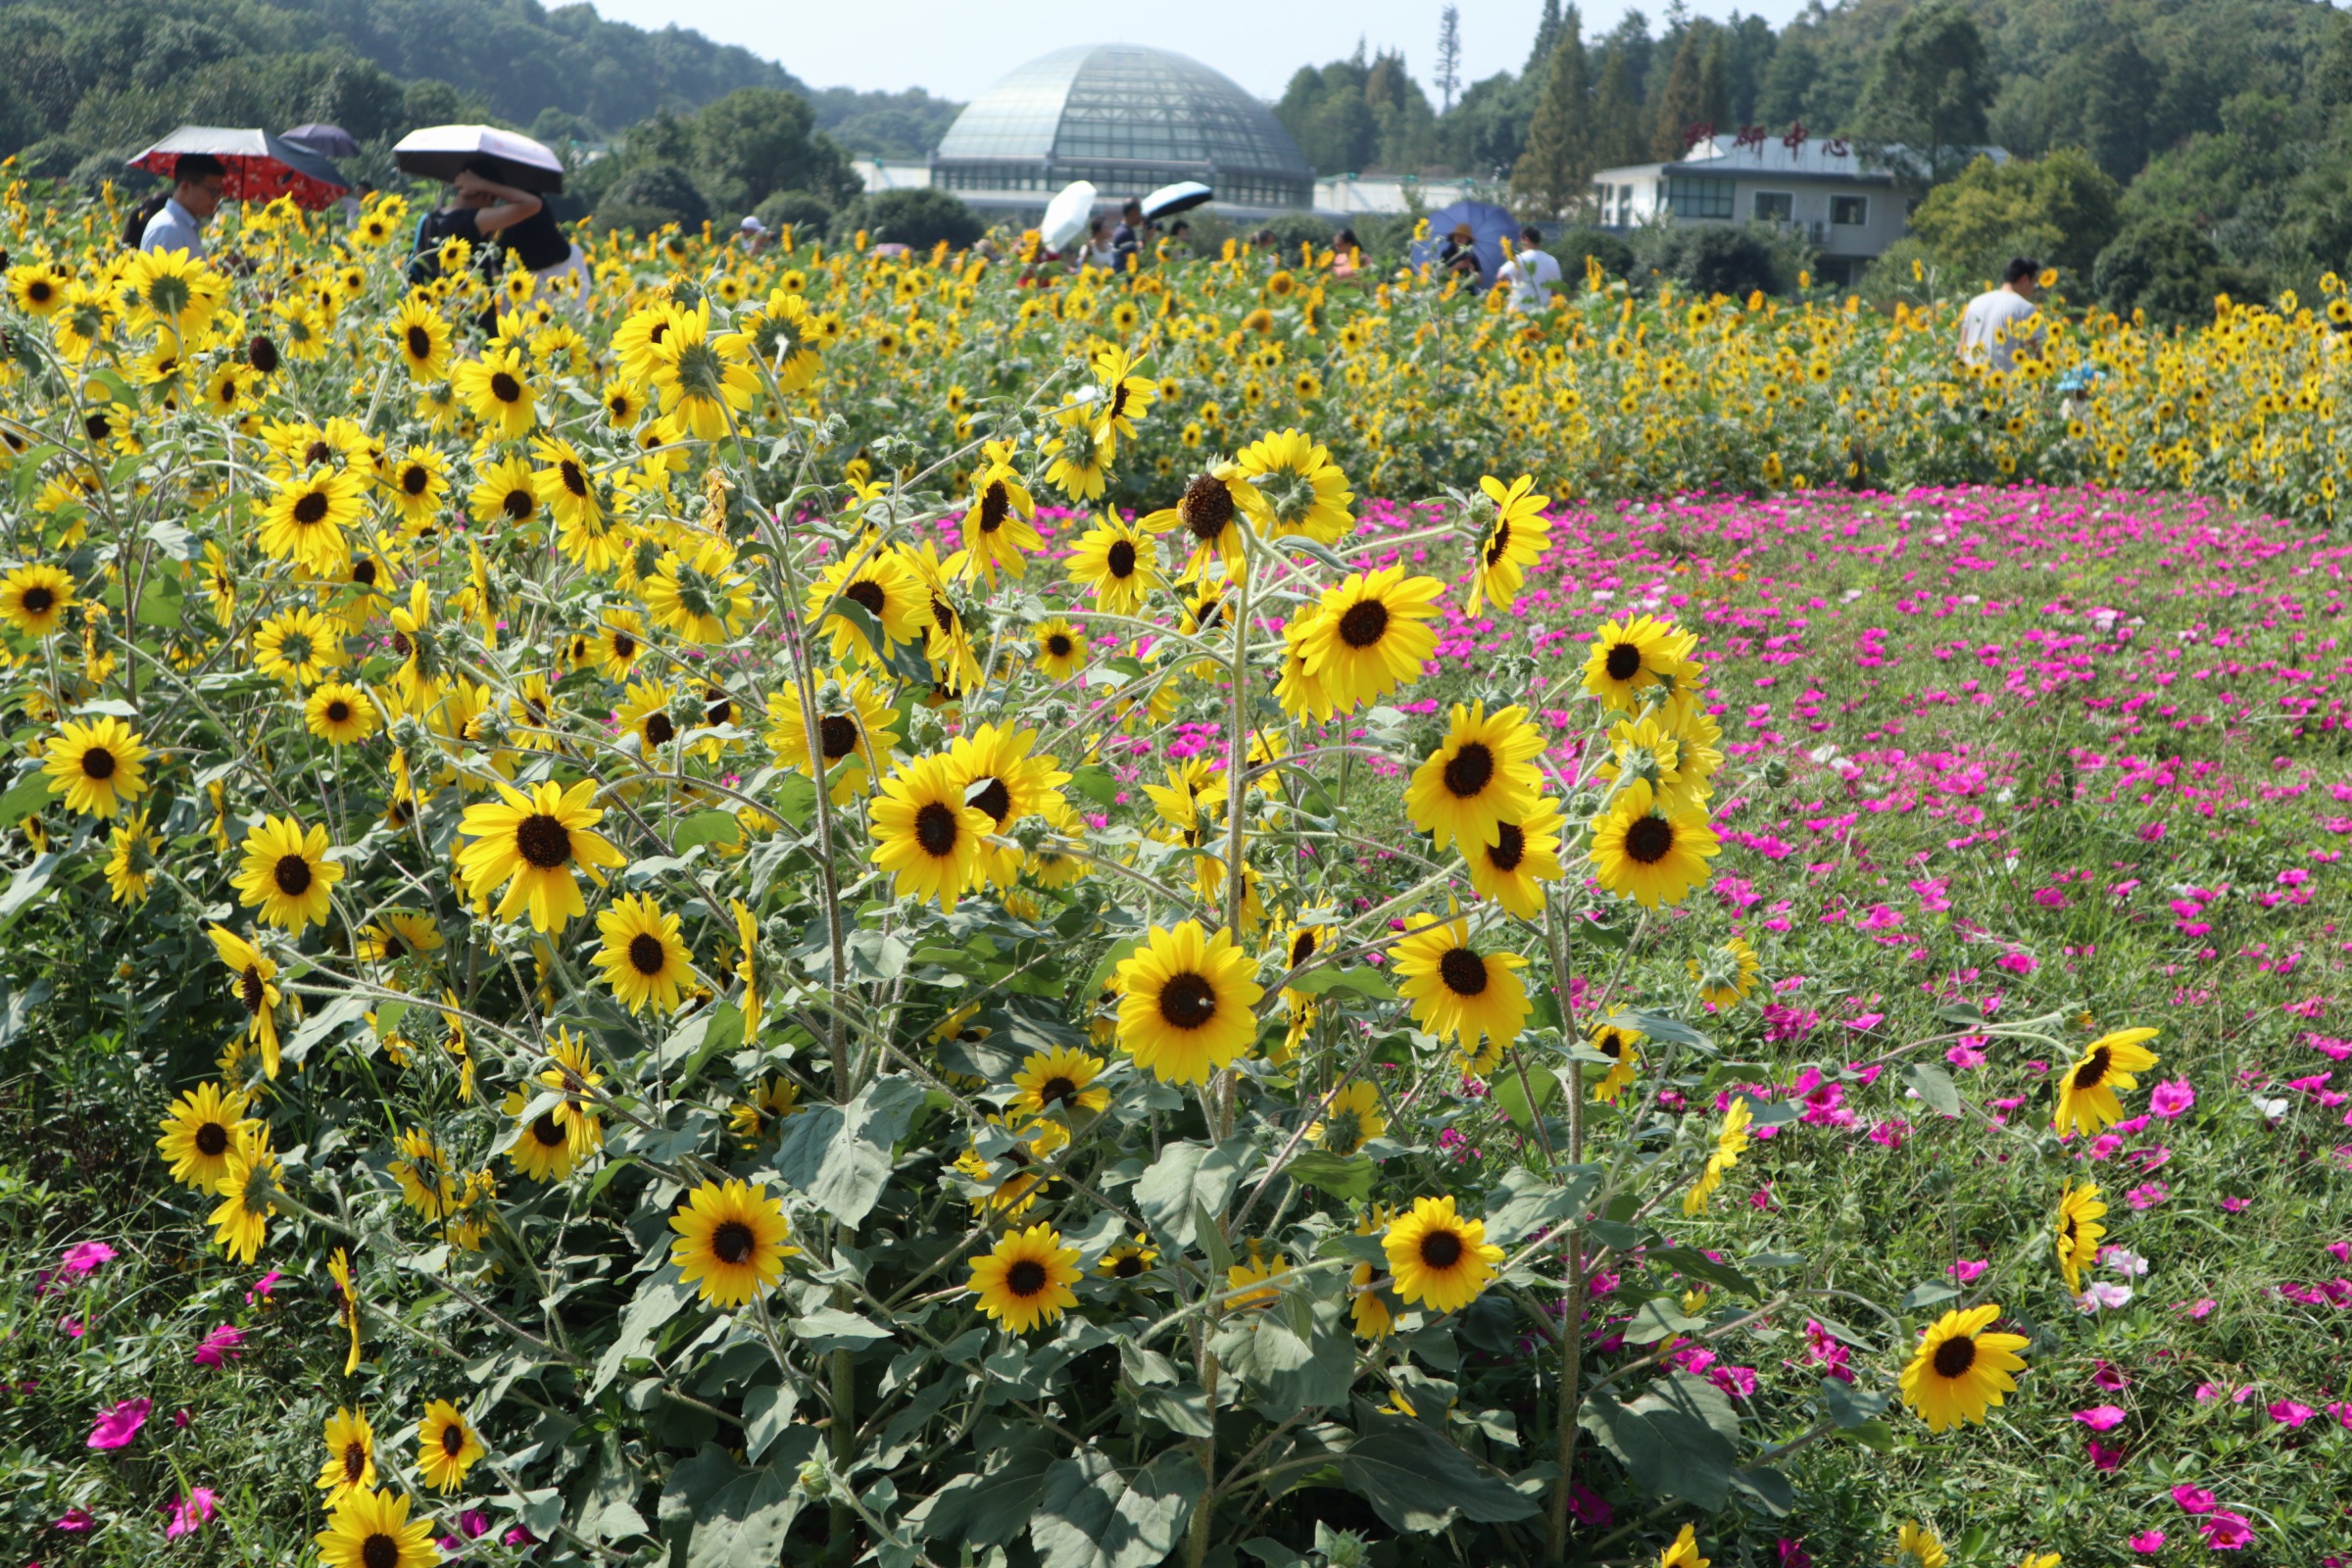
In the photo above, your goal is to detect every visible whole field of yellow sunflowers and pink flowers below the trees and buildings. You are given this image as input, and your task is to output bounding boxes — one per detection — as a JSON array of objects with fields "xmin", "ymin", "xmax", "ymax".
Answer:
[{"xmin": 0, "ymin": 186, "xmax": 2352, "ymax": 1568}]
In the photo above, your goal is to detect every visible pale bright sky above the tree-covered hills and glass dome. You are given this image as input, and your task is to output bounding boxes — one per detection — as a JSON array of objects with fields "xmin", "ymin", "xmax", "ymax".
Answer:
[{"xmin": 578, "ymin": 0, "xmax": 1801, "ymax": 101}]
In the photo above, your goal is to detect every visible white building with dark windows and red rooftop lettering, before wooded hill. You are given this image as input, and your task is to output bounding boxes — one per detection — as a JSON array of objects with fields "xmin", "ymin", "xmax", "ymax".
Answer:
[{"xmin": 1592, "ymin": 134, "xmax": 1947, "ymax": 282}]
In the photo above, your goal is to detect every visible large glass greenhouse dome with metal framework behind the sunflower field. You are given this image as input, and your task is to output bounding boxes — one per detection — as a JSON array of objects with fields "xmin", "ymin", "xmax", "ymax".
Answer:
[{"xmin": 939, "ymin": 45, "xmax": 1315, "ymax": 181}]
